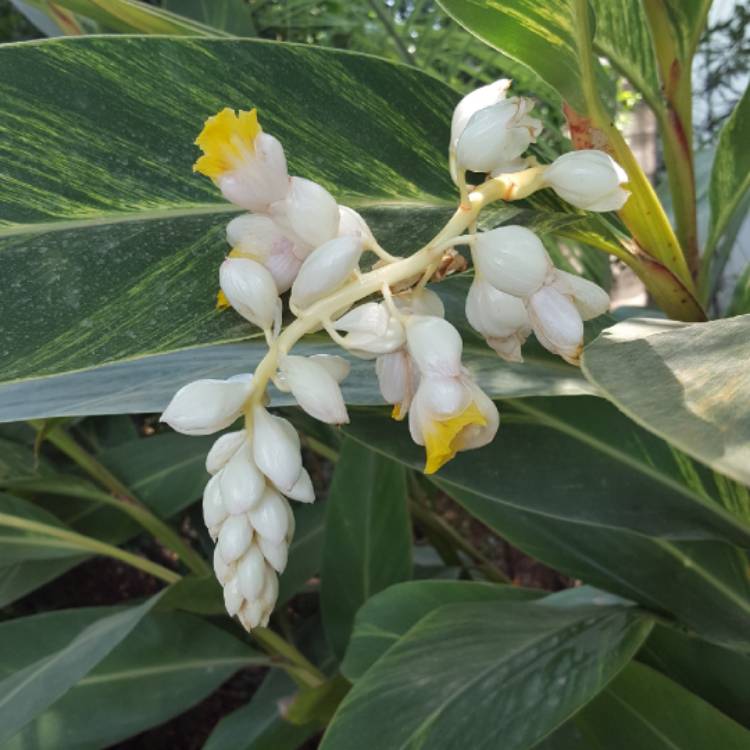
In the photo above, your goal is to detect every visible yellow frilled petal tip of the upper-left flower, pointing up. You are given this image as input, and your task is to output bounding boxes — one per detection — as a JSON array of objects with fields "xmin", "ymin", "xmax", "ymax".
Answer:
[{"xmin": 193, "ymin": 107, "xmax": 261, "ymax": 179}]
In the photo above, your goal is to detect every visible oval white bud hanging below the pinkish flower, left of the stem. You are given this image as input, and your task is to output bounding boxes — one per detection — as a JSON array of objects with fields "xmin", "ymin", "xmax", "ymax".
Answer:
[{"xmin": 219, "ymin": 258, "xmax": 281, "ymax": 330}]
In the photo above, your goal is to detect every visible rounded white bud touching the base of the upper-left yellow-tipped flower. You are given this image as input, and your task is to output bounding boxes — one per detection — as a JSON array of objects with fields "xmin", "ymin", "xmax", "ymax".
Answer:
[{"xmin": 271, "ymin": 177, "xmax": 339, "ymax": 247}]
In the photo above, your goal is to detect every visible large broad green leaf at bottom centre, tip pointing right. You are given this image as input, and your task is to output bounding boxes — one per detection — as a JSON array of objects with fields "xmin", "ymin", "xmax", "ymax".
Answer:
[{"xmin": 321, "ymin": 602, "xmax": 651, "ymax": 750}]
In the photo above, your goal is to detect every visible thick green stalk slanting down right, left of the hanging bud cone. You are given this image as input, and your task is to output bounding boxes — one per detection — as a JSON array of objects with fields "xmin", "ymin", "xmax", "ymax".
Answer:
[{"xmin": 30, "ymin": 420, "xmax": 211, "ymax": 576}]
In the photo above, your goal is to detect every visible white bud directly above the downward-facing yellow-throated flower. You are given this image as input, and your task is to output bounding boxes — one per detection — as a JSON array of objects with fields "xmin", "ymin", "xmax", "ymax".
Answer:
[{"xmin": 406, "ymin": 315, "xmax": 463, "ymax": 377}]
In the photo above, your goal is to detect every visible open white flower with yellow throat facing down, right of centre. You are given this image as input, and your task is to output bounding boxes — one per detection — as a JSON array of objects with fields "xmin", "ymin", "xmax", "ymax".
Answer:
[{"xmin": 409, "ymin": 374, "xmax": 500, "ymax": 474}]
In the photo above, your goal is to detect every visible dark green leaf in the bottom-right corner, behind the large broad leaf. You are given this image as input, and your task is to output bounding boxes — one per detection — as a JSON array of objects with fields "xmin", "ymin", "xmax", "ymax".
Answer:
[{"xmin": 576, "ymin": 663, "xmax": 750, "ymax": 750}]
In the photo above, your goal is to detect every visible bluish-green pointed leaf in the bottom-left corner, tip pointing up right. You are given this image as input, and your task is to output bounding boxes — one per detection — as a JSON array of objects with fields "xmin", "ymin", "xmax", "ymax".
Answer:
[{"xmin": 0, "ymin": 595, "xmax": 159, "ymax": 742}]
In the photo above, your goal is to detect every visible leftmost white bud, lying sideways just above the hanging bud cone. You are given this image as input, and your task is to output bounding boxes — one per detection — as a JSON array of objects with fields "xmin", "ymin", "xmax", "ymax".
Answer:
[{"xmin": 159, "ymin": 375, "xmax": 253, "ymax": 435}]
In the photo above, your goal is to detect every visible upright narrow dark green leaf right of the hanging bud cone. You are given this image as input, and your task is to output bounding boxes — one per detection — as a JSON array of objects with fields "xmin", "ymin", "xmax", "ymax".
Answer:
[{"xmin": 321, "ymin": 440, "xmax": 412, "ymax": 658}]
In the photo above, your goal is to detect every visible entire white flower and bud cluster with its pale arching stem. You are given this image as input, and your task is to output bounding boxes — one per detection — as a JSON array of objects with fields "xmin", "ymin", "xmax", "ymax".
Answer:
[{"xmin": 161, "ymin": 81, "xmax": 627, "ymax": 630}]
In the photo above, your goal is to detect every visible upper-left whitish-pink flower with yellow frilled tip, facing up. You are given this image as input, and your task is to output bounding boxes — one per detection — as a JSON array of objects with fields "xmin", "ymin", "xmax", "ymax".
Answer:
[{"xmin": 193, "ymin": 108, "xmax": 289, "ymax": 211}]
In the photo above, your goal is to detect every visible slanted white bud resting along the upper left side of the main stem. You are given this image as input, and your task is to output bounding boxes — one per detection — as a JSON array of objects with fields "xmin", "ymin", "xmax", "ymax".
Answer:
[{"xmin": 290, "ymin": 237, "xmax": 362, "ymax": 308}]
